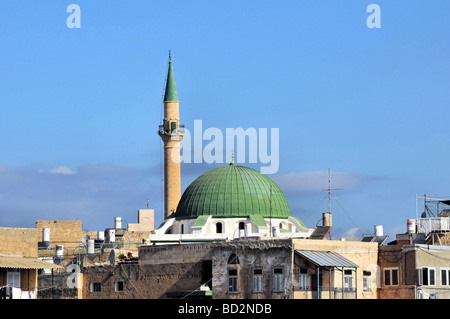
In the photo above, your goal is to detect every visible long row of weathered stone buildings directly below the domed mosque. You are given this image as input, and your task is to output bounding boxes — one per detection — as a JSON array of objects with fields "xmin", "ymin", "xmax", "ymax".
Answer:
[{"xmin": 78, "ymin": 238, "xmax": 380, "ymax": 299}]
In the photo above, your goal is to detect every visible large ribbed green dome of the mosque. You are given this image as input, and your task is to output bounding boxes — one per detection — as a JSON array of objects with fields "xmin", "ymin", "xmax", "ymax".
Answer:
[{"xmin": 175, "ymin": 163, "xmax": 291, "ymax": 219}]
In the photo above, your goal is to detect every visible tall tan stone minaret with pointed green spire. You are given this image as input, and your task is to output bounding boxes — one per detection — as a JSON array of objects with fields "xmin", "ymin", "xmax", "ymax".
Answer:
[{"xmin": 158, "ymin": 51, "xmax": 184, "ymax": 220}]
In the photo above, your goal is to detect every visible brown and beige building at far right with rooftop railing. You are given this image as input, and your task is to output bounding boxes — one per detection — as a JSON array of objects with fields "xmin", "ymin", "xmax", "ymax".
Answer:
[{"xmin": 378, "ymin": 196, "xmax": 450, "ymax": 299}]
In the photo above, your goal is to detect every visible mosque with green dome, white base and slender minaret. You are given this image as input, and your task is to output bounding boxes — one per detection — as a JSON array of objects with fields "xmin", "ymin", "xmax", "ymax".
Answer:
[{"xmin": 149, "ymin": 52, "xmax": 314, "ymax": 242}]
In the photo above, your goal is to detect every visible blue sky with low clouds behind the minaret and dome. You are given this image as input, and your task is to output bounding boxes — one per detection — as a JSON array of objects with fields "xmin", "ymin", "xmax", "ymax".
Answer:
[{"xmin": 0, "ymin": 0, "xmax": 450, "ymax": 240}]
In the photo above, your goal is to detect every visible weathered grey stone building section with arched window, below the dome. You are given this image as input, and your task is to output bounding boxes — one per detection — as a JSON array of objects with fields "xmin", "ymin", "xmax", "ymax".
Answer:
[{"xmin": 212, "ymin": 239, "xmax": 295, "ymax": 299}]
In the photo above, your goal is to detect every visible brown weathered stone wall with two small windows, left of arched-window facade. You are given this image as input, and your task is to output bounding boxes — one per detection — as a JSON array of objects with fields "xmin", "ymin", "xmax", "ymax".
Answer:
[{"xmin": 83, "ymin": 243, "xmax": 216, "ymax": 299}]
